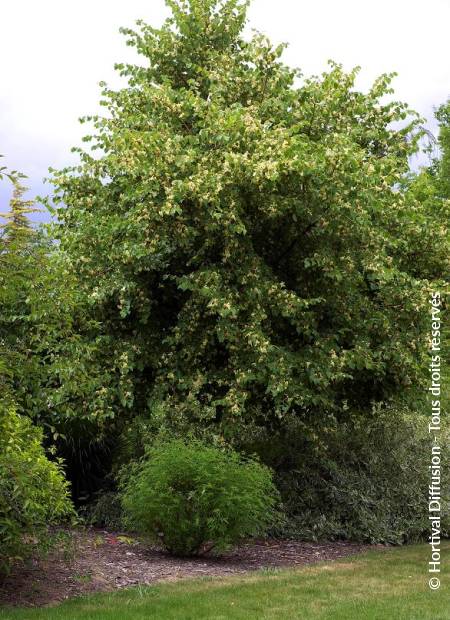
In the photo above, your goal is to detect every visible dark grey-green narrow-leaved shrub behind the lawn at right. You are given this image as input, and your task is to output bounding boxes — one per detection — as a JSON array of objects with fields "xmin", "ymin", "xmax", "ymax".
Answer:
[{"xmin": 237, "ymin": 408, "xmax": 449, "ymax": 544}]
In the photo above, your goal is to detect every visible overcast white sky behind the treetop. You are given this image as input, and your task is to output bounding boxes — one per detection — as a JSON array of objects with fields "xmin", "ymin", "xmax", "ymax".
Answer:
[{"xmin": 0, "ymin": 0, "xmax": 450, "ymax": 219}]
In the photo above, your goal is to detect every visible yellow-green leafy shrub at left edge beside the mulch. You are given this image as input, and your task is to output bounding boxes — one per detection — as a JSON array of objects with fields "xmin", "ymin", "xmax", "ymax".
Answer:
[{"xmin": 0, "ymin": 402, "xmax": 72, "ymax": 573}]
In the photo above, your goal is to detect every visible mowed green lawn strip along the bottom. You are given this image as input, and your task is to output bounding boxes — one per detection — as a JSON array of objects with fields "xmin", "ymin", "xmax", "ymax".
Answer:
[{"xmin": 0, "ymin": 542, "xmax": 450, "ymax": 620}]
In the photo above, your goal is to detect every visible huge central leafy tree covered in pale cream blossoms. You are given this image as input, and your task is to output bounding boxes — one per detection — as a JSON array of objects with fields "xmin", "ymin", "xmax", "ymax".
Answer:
[{"xmin": 52, "ymin": 0, "xmax": 441, "ymax": 436}]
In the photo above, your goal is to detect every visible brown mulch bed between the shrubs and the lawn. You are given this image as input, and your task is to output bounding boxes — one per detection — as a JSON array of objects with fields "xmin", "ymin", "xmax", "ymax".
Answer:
[{"xmin": 0, "ymin": 529, "xmax": 376, "ymax": 607}]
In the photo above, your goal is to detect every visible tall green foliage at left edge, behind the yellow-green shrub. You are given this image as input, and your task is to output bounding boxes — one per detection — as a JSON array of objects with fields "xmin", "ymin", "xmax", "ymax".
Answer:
[{"xmin": 0, "ymin": 159, "xmax": 121, "ymax": 498}]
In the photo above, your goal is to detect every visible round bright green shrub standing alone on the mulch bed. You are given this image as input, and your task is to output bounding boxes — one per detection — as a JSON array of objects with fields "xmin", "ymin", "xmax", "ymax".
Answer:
[{"xmin": 122, "ymin": 440, "xmax": 278, "ymax": 556}]
